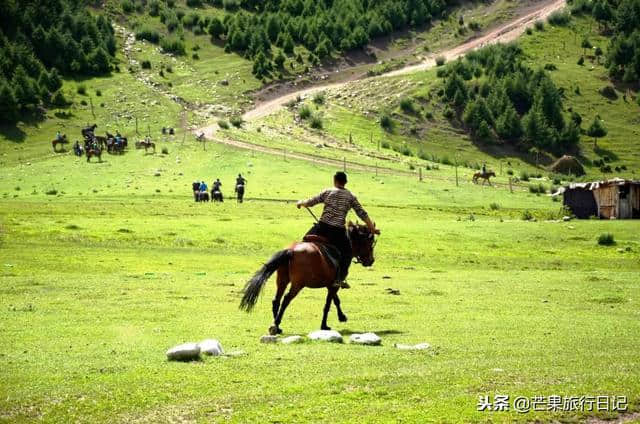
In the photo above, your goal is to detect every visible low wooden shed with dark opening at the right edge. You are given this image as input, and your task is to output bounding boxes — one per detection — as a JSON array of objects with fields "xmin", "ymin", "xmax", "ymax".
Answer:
[{"xmin": 555, "ymin": 178, "xmax": 640, "ymax": 219}]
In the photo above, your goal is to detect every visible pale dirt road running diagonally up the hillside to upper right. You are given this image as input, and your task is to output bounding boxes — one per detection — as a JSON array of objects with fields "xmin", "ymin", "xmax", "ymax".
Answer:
[{"xmin": 198, "ymin": 0, "xmax": 565, "ymax": 137}]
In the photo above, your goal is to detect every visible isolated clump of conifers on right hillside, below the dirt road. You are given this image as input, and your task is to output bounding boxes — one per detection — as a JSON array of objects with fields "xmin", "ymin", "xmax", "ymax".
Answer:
[{"xmin": 439, "ymin": 44, "xmax": 581, "ymax": 154}]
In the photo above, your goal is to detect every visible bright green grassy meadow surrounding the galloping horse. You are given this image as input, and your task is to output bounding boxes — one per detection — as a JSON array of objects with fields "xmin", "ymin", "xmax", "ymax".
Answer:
[{"xmin": 0, "ymin": 135, "xmax": 640, "ymax": 422}]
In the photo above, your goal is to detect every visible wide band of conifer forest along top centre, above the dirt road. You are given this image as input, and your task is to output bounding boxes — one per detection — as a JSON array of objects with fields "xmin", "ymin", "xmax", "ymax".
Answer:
[{"xmin": 123, "ymin": 0, "xmax": 452, "ymax": 78}]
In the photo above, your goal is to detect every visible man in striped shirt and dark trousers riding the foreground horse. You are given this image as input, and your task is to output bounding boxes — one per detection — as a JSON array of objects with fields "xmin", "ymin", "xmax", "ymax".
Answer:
[{"xmin": 296, "ymin": 172, "xmax": 380, "ymax": 288}]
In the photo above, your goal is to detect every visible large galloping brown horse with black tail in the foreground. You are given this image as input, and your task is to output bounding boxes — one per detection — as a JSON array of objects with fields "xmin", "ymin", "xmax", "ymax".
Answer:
[{"xmin": 240, "ymin": 222, "xmax": 379, "ymax": 335}]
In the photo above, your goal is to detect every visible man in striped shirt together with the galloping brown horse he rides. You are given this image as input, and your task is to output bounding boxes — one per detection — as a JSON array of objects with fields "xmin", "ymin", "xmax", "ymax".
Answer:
[{"xmin": 240, "ymin": 172, "xmax": 380, "ymax": 335}]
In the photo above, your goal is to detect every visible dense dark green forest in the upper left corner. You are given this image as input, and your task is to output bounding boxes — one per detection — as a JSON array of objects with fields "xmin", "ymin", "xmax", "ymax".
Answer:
[{"xmin": 0, "ymin": 0, "xmax": 116, "ymax": 123}]
